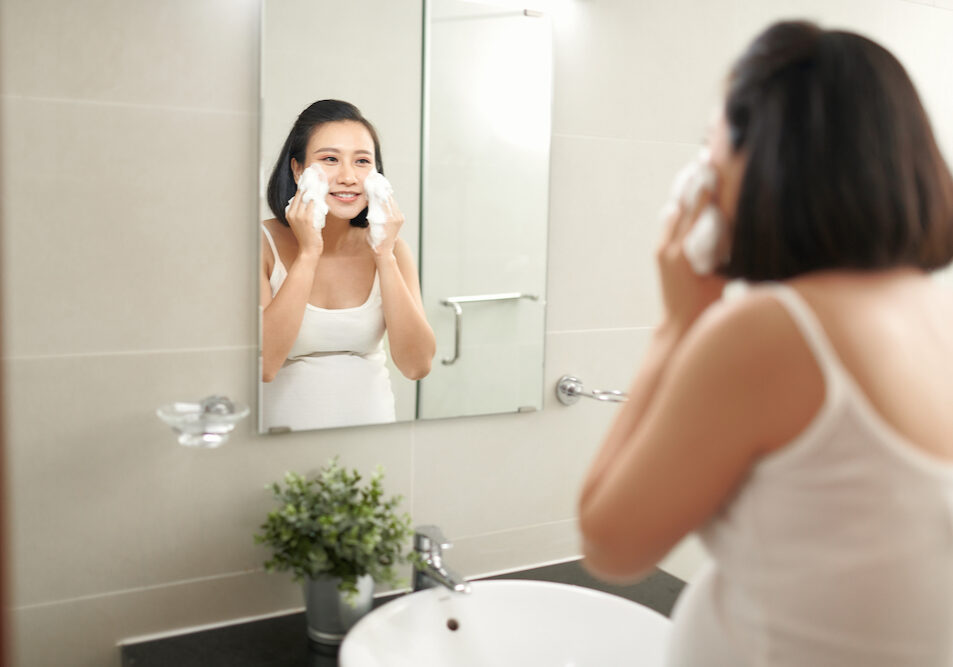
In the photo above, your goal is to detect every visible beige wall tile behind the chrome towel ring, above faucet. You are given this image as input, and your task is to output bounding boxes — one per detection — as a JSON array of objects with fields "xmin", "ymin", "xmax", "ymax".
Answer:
[{"xmin": 413, "ymin": 330, "xmax": 649, "ymax": 539}]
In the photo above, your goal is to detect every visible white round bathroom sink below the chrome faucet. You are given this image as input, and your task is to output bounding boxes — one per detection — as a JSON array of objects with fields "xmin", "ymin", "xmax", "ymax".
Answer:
[{"xmin": 338, "ymin": 580, "xmax": 670, "ymax": 667}]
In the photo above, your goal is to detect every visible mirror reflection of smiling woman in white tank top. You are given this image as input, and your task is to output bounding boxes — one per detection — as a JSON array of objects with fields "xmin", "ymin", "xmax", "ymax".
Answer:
[{"xmin": 261, "ymin": 100, "xmax": 435, "ymax": 430}]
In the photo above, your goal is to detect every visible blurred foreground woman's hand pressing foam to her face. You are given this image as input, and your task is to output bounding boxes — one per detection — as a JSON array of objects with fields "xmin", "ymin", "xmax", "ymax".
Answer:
[{"xmin": 656, "ymin": 191, "xmax": 727, "ymax": 336}]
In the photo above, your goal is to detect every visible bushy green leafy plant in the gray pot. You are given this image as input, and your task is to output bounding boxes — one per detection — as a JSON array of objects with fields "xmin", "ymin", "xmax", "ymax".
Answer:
[{"xmin": 255, "ymin": 457, "xmax": 413, "ymax": 599}]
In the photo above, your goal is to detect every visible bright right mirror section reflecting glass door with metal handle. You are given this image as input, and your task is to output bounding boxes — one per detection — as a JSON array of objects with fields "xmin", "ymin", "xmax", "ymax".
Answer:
[{"xmin": 418, "ymin": 0, "xmax": 552, "ymax": 419}]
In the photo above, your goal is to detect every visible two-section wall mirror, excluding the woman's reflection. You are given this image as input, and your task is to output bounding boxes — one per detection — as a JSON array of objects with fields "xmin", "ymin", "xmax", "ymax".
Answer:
[{"xmin": 259, "ymin": 0, "xmax": 552, "ymax": 433}]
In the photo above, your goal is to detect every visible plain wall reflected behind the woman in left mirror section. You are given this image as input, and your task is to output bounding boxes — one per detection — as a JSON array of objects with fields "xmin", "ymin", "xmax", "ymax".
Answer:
[{"xmin": 258, "ymin": 0, "xmax": 423, "ymax": 423}]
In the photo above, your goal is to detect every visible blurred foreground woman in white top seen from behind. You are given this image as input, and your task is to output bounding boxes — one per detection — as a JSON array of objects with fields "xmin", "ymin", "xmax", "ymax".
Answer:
[{"xmin": 579, "ymin": 23, "xmax": 953, "ymax": 667}]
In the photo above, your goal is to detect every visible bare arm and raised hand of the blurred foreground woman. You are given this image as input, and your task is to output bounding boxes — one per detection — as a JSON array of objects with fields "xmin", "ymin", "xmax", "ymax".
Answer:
[{"xmin": 579, "ymin": 192, "xmax": 824, "ymax": 579}]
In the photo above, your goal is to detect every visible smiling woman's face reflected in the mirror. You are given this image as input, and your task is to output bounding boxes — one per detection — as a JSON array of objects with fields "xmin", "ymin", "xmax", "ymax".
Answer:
[{"xmin": 291, "ymin": 120, "xmax": 375, "ymax": 220}]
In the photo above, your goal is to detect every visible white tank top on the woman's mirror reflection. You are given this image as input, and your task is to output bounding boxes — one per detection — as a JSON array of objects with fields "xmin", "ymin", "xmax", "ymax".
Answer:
[{"xmin": 261, "ymin": 225, "xmax": 396, "ymax": 431}]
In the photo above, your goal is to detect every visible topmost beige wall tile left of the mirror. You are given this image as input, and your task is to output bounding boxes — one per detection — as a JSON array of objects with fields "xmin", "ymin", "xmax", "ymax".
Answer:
[{"xmin": 0, "ymin": 0, "xmax": 260, "ymax": 113}]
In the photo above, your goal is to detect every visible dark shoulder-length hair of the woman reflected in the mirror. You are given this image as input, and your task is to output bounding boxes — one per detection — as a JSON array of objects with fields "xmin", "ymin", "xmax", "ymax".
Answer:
[{"xmin": 267, "ymin": 100, "xmax": 384, "ymax": 227}]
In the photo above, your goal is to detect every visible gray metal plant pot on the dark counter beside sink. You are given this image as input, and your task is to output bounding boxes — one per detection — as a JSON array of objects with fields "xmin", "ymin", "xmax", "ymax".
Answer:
[{"xmin": 304, "ymin": 575, "xmax": 374, "ymax": 644}]
